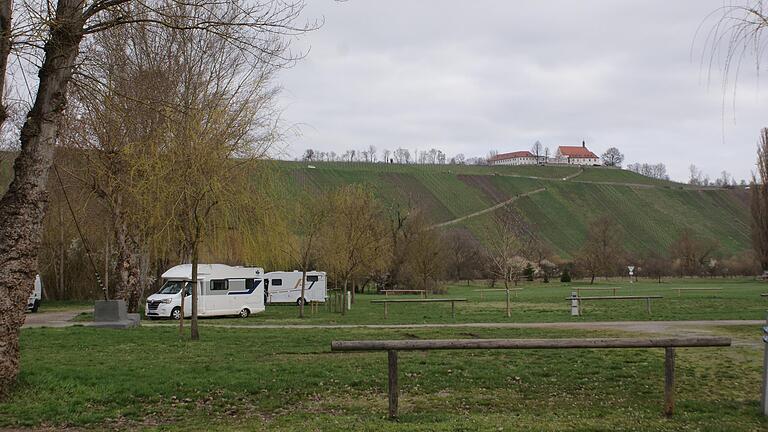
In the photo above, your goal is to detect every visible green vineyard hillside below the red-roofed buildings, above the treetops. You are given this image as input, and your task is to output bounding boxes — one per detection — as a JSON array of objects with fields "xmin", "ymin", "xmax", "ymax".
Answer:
[{"xmin": 277, "ymin": 162, "xmax": 750, "ymax": 257}]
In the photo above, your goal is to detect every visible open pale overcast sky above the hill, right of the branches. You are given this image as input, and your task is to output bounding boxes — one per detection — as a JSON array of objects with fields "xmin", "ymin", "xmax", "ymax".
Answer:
[{"xmin": 280, "ymin": 0, "xmax": 768, "ymax": 180}]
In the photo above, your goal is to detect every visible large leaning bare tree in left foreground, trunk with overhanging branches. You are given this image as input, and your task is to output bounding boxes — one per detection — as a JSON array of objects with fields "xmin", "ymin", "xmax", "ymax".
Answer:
[{"xmin": 0, "ymin": 0, "xmax": 316, "ymax": 390}]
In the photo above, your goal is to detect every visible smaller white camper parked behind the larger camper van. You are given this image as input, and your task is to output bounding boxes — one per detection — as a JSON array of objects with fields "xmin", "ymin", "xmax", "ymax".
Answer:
[{"xmin": 264, "ymin": 270, "xmax": 327, "ymax": 305}]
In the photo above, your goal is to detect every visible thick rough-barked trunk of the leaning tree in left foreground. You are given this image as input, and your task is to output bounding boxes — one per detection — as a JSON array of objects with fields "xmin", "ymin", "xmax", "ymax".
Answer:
[{"xmin": 0, "ymin": 0, "xmax": 85, "ymax": 392}]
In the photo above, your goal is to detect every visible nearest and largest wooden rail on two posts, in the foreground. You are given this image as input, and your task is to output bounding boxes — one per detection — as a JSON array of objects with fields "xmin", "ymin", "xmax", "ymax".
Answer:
[{"xmin": 331, "ymin": 337, "xmax": 731, "ymax": 418}]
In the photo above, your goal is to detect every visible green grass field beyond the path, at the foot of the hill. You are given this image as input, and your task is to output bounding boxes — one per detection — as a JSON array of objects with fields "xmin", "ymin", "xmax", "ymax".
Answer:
[{"xmin": 180, "ymin": 279, "xmax": 768, "ymax": 325}]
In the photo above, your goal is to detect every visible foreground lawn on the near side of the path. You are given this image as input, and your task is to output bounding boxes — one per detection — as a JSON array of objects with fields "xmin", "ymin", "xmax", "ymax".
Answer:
[{"xmin": 0, "ymin": 327, "xmax": 768, "ymax": 431}]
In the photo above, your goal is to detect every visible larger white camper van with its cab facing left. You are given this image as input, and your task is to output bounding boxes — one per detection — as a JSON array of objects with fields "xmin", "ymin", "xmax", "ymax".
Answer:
[{"xmin": 144, "ymin": 264, "xmax": 264, "ymax": 319}]
